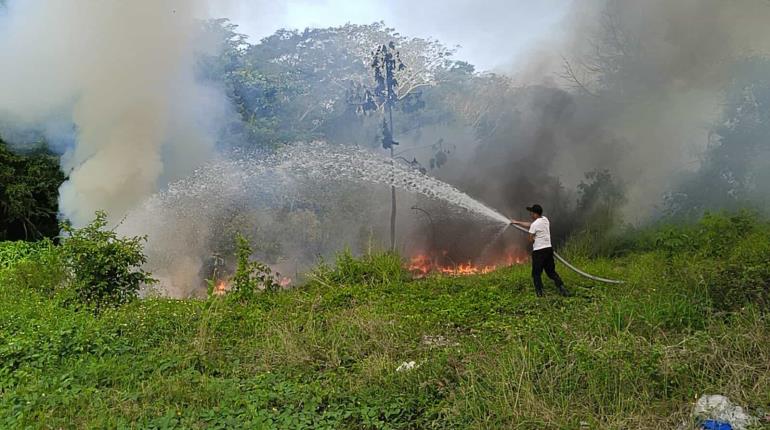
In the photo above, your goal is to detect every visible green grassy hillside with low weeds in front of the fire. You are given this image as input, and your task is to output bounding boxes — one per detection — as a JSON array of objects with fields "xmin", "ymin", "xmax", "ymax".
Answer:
[{"xmin": 0, "ymin": 214, "xmax": 770, "ymax": 429}]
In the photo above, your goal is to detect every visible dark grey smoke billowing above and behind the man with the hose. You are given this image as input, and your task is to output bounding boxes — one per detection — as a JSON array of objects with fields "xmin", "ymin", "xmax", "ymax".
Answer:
[{"xmin": 400, "ymin": 0, "xmax": 770, "ymax": 255}]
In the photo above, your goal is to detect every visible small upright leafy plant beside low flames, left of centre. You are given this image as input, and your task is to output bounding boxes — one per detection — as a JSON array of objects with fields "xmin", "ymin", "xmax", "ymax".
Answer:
[{"xmin": 232, "ymin": 234, "xmax": 280, "ymax": 301}]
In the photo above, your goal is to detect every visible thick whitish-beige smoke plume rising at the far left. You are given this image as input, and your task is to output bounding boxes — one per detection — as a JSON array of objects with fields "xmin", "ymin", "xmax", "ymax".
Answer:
[{"xmin": 0, "ymin": 0, "xmax": 224, "ymax": 225}]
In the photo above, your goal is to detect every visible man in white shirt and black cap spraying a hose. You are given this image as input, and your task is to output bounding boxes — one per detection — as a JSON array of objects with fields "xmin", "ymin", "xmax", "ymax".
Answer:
[{"xmin": 511, "ymin": 205, "xmax": 570, "ymax": 297}]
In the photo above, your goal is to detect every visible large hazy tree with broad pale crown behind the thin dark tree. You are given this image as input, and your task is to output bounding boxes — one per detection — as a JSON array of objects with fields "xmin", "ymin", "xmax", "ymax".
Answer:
[{"xmin": 200, "ymin": 20, "xmax": 453, "ymax": 149}]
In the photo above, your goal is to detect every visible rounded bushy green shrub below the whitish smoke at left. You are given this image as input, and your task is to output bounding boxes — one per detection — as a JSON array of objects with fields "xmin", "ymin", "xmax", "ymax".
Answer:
[{"xmin": 62, "ymin": 211, "xmax": 157, "ymax": 311}]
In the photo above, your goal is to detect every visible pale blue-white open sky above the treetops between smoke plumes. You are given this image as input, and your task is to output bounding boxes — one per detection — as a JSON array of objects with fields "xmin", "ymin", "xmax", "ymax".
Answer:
[{"xmin": 212, "ymin": 0, "xmax": 570, "ymax": 70}]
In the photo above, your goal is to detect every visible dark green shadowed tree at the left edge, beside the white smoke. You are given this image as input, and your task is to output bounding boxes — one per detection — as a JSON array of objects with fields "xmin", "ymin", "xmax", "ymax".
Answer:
[{"xmin": 0, "ymin": 140, "xmax": 65, "ymax": 240}]
